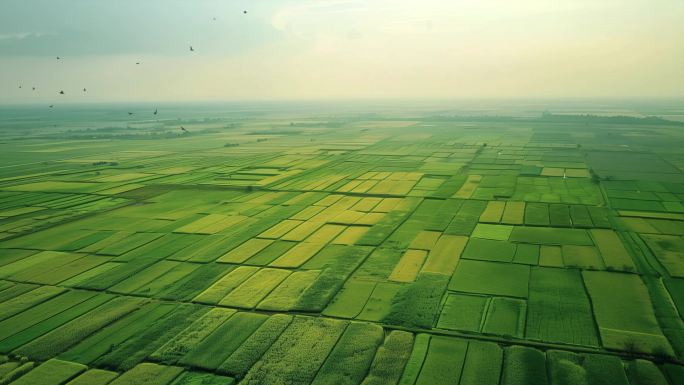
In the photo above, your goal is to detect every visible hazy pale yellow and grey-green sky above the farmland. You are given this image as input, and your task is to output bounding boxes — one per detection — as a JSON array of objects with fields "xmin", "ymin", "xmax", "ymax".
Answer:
[{"xmin": 0, "ymin": 0, "xmax": 684, "ymax": 103}]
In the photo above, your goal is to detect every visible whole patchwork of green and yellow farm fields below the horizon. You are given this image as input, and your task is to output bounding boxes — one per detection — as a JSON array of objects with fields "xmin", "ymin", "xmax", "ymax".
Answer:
[{"xmin": 0, "ymin": 108, "xmax": 684, "ymax": 385}]
